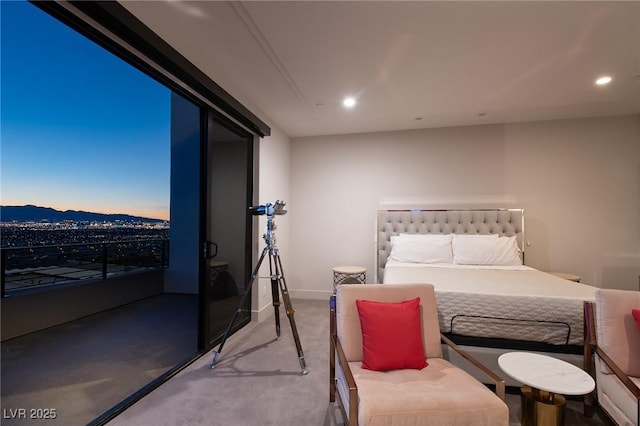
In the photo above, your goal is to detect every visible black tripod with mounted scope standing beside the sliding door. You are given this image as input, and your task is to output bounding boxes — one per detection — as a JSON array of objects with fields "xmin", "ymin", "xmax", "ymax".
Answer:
[{"xmin": 209, "ymin": 201, "xmax": 309, "ymax": 375}]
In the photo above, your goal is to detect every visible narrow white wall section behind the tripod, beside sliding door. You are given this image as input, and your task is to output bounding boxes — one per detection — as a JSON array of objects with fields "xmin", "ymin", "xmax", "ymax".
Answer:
[{"xmin": 251, "ymin": 123, "xmax": 295, "ymax": 318}]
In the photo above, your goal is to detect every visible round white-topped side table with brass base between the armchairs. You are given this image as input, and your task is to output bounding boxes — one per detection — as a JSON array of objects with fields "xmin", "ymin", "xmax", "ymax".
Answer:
[{"xmin": 498, "ymin": 352, "xmax": 595, "ymax": 426}]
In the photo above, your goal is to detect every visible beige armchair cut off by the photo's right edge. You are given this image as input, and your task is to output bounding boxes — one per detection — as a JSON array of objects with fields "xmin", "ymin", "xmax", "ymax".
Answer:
[{"xmin": 590, "ymin": 289, "xmax": 640, "ymax": 426}]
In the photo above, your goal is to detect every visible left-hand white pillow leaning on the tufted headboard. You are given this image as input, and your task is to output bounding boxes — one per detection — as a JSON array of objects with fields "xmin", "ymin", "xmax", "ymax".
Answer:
[{"xmin": 389, "ymin": 234, "xmax": 453, "ymax": 263}]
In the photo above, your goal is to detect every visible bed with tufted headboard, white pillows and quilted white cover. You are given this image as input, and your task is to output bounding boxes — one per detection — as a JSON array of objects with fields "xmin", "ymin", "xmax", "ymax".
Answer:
[{"xmin": 376, "ymin": 209, "xmax": 595, "ymax": 386}]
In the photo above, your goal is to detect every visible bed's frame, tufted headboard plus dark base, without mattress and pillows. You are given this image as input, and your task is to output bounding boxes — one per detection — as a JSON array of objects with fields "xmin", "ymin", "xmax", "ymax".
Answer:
[{"xmin": 375, "ymin": 208, "xmax": 589, "ymax": 386}]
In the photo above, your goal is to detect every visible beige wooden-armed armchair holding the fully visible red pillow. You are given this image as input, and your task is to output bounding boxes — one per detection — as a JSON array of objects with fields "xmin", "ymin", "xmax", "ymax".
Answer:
[{"xmin": 330, "ymin": 284, "xmax": 509, "ymax": 426}]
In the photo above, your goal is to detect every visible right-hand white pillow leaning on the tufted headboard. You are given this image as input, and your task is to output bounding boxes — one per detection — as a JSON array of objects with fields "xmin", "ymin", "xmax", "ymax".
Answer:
[{"xmin": 451, "ymin": 234, "xmax": 522, "ymax": 266}]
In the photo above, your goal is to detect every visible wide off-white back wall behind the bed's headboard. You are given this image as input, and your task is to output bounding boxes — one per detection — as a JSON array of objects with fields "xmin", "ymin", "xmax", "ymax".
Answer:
[{"xmin": 286, "ymin": 116, "xmax": 640, "ymax": 298}]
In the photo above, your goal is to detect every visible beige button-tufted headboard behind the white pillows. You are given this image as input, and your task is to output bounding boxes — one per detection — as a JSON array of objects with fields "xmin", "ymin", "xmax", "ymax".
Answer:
[{"xmin": 376, "ymin": 209, "xmax": 525, "ymax": 282}]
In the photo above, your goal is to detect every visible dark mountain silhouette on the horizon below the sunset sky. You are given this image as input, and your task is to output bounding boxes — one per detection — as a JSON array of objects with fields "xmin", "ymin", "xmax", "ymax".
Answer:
[{"xmin": 0, "ymin": 205, "xmax": 163, "ymax": 222}]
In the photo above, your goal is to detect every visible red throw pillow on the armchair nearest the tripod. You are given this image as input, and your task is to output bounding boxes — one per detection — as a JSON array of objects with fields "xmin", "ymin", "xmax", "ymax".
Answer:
[{"xmin": 356, "ymin": 297, "xmax": 429, "ymax": 371}]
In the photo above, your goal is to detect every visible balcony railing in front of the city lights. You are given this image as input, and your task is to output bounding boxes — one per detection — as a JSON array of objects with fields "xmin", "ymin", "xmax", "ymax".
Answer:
[{"xmin": 0, "ymin": 239, "xmax": 169, "ymax": 297}]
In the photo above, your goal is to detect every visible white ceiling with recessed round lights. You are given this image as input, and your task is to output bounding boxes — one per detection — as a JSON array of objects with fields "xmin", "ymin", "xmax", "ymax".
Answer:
[{"xmin": 122, "ymin": 0, "xmax": 640, "ymax": 137}]
